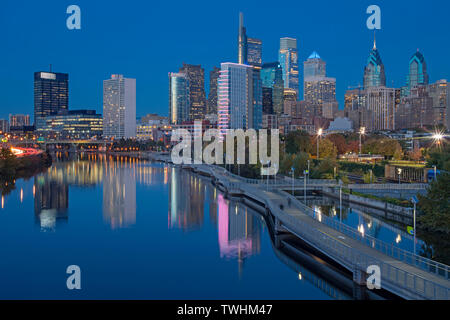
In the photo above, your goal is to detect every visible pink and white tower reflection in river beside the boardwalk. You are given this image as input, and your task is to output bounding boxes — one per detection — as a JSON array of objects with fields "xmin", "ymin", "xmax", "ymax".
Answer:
[{"xmin": 217, "ymin": 194, "xmax": 261, "ymax": 274}]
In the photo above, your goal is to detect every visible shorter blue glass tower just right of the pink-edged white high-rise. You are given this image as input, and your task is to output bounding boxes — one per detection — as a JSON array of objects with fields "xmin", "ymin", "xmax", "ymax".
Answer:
[{"xmin": 261, "ymin": 62, "xmax": 284, "ymax": 114}]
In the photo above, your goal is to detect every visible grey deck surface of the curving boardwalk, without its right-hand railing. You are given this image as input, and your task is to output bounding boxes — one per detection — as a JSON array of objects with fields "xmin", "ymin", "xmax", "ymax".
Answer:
[{"xmin": 214, "ymin": 168, "xmax": 450, "ymax": 299}]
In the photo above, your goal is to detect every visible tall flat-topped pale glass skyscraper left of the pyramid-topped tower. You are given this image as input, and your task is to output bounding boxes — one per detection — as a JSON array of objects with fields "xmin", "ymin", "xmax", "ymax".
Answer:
[{"xmin": 278, "ymin": 38, "xmax": 299, "ymax": 97}]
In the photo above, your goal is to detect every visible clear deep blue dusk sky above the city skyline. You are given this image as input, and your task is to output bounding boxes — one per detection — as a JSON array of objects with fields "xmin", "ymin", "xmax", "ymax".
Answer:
[{"xmin": 0, "ymin": 0, "xmax": 450, "ymax": 118}]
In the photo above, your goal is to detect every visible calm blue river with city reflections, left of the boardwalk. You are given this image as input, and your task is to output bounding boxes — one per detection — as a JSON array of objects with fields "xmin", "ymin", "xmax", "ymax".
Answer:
[{"xmin": 0, "ymin": 155, "xmax": 344, "ymax": 299}]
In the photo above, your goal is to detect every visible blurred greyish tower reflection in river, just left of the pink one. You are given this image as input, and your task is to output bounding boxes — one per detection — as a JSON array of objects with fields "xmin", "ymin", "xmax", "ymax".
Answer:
[{"xmin": 168, "ymin": 168, "xmax": 206, "ymax": 231}]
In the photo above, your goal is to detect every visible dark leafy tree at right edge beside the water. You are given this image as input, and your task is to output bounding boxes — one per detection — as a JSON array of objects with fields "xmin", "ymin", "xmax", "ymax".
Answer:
[{"xmin": 418, "ymin": 173, "xmax": 450, "ymax": 234}]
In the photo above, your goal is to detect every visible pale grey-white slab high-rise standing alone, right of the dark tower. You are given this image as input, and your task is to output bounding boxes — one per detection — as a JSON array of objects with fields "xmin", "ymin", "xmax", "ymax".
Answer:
[{"xmin": 103, "ymin": 74, "xmax": 136, "ymax": 139}]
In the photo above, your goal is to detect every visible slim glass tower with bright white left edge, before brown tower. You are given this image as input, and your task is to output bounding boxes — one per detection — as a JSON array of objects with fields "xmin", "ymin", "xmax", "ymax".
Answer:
[{"xmin": 169, "ymin": 72, "xmax": 190, "ymax": 124}]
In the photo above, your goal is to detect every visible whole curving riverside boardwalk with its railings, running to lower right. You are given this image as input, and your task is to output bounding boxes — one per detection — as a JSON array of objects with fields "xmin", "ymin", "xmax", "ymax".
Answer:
[{"xmin": 145, "ymin": 152, "xmax": 450, "ymax": 300}]
